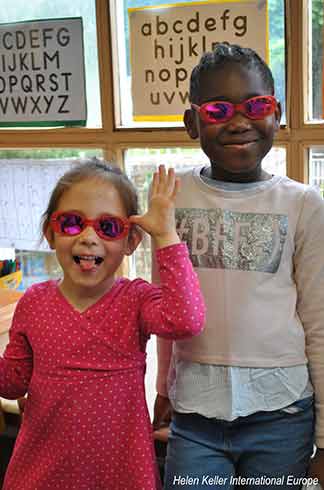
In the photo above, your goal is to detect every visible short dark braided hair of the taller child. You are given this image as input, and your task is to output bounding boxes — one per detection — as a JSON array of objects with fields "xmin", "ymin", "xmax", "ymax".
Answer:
[{"xmin": 189, "ymin": 42, "xmax": 274, "ymax": 104}]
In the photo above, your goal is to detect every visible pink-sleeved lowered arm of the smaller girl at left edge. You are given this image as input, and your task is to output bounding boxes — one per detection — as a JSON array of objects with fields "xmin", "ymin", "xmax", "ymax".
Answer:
[{"xmin": 0, "ymin": 297, "xmax": 33, "ymax": 400}]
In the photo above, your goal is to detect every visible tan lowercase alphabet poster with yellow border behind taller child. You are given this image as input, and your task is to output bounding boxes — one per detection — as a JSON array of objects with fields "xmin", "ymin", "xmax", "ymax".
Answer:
[{"xmin": 128, "ymin": 0, "xmax": 268, "ymax": 121}]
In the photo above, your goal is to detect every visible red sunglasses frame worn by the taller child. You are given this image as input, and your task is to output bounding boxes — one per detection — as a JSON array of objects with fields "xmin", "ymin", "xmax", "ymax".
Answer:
[{"xmin": 191, "ymin": 95, "xmax": 278, "ymax": 124}]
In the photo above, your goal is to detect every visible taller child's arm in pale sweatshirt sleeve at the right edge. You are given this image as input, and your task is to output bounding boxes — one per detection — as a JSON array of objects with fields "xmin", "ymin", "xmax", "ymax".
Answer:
[{"xmin": 294, "ymin": 188, "xmax": 324, "ymax": 460}]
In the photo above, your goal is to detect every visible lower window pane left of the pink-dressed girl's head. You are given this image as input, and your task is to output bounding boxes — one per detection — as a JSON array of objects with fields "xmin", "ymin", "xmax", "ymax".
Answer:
[{"xmin": 0, "ymin": 148, "xmax": 102, "ymax": 291}]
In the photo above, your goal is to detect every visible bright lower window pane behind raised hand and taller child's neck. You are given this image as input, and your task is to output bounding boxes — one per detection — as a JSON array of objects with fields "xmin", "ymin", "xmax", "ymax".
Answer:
[{"xmin": 125, "ymin": 147, "xmax": 286, "ymax": 281}]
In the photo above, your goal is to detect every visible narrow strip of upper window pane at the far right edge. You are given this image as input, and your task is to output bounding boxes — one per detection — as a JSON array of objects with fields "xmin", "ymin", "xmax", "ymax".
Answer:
[{"xmin": 308, "ymin": 0, "xmax": 324, "ymax": 122}]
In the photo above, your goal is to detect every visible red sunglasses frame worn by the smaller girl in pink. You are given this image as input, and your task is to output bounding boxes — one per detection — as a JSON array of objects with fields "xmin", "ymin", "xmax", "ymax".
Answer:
[{"xmin": 49, "ymin": 210, "xmax": 131, "ymax": 241}]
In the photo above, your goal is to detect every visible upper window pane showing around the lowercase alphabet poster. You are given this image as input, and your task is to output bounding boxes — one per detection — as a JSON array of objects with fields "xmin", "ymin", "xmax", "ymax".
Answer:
[{"xmin": 114, "ymin": 0, "xmax": 285, "ymax": 127}]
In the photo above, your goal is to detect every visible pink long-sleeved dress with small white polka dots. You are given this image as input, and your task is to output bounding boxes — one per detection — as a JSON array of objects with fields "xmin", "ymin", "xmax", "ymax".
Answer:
[{"xmin": 0, "ymin": 244, "xmax": 205, "ymax": 490}]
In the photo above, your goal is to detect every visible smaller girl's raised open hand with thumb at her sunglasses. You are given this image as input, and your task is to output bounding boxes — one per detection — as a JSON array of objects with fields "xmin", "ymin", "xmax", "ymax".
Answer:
[{"xmin": 129, "ymin": 165, "xmax": 180, "ymax": 248}]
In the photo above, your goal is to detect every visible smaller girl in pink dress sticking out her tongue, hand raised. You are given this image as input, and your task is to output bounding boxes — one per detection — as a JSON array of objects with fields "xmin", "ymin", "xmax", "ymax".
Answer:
[{"xmin": 0, "ymin": 160, "xmax": 204, "ymax": 490}]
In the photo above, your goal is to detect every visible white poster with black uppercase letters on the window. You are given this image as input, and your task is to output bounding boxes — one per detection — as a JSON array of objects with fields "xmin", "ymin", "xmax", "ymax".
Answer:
[{"xmin": 0, "ymin": 17, "xmax": 87, "ymax": 127}]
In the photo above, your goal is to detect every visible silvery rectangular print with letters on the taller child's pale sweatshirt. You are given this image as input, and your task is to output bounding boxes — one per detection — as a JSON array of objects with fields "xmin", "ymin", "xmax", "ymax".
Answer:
[{"xmin": 176, "ymin": 208, "xmax": 288, "ymax": 273}]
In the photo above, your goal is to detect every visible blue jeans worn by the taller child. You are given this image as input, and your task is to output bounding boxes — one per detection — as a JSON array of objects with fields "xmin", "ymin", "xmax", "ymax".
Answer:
[{"xmin": 164, "ymin": 397, "xmax": 314, "ymax": 490}]
